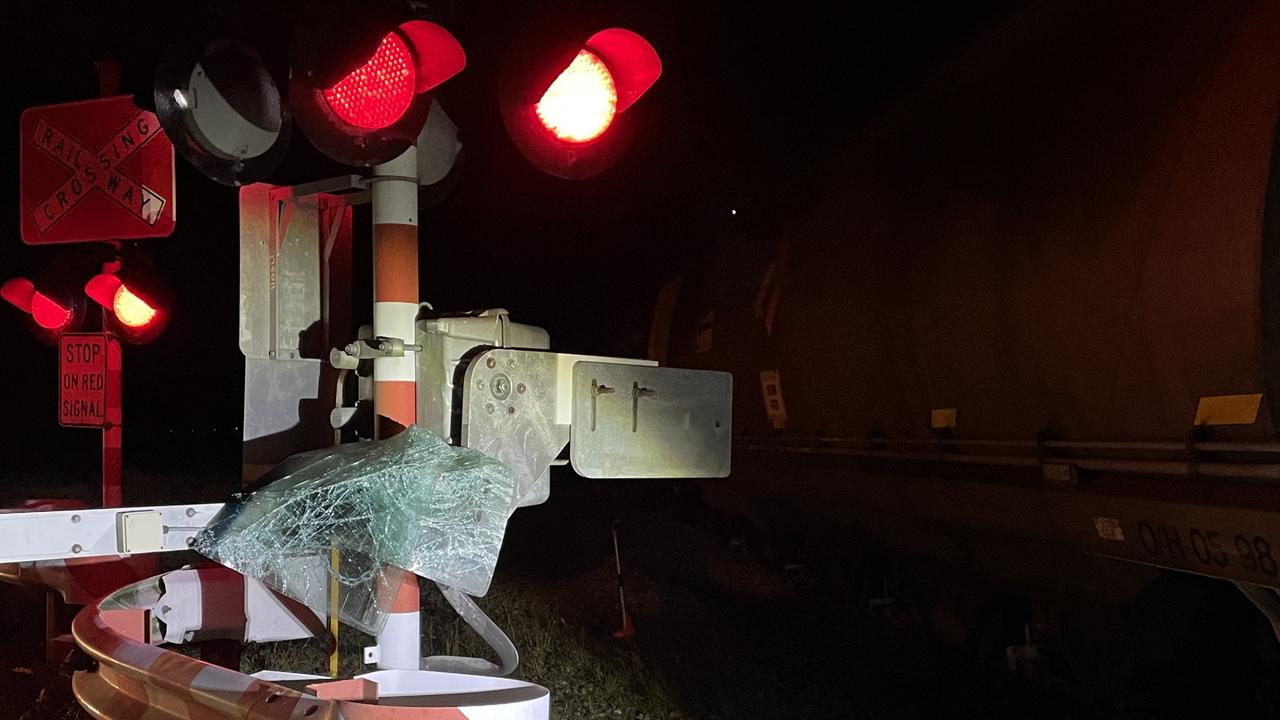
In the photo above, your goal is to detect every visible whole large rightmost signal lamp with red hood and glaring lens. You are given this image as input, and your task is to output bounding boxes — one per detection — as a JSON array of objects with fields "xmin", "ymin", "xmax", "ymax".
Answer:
[{"xmin": 500, "ymin": 28, "xmax": 662, "ymax": 179}]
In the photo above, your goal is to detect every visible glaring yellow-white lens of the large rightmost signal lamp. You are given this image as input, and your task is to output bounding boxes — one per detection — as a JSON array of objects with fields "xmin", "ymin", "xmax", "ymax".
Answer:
[{"xmin": 534, "ymin": 50, "xmax": 618, "ymax": 142}]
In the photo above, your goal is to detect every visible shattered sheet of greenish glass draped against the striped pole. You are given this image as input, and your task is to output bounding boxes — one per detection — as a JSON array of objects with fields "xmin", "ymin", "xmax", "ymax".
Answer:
[{"xmin": 192, "ymin": 427, "xmax": 515, "ymax": 634}]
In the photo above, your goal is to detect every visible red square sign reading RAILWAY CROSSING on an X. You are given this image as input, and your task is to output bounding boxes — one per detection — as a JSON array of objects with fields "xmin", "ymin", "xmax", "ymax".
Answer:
[{"xmin": 19, "ymin": 96, "xmax": 177, "ymax": 245}]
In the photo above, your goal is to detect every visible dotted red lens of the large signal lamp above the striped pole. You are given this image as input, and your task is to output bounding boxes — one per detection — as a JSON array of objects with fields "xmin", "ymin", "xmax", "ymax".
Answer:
[{"xmin": 324, "ymin": 32, "xmax": 415, "ymax": 129}]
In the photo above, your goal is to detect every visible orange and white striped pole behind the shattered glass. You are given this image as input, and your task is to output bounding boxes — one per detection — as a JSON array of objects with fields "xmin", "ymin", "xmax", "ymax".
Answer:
[{"xmin": 371, "ymin": 147, "xmax": 422, "ymax": 670}]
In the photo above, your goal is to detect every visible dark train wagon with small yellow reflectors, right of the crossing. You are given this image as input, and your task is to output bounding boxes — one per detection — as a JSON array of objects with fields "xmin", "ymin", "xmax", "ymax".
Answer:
[{"xmin": 652, "ymin": 0, "xmax": 1280, "ymax": 653}]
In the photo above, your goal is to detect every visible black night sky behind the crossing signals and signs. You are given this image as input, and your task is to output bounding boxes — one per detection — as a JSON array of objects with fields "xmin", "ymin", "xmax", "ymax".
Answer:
[{"xmin": 0, "ymin": 0, "xmax": 1025, "ymax": 475}]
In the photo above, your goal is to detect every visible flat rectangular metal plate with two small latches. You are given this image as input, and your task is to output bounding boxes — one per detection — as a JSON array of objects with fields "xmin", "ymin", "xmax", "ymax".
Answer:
[{"xmin": 570, "ymin": 363, "xmax": 733, "ymax": 478}]
